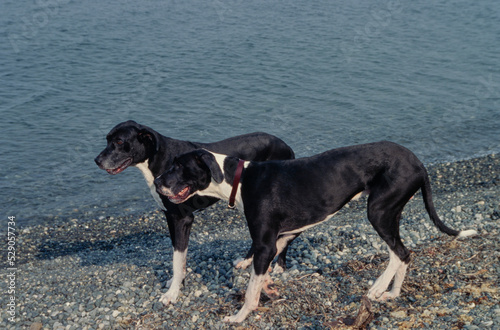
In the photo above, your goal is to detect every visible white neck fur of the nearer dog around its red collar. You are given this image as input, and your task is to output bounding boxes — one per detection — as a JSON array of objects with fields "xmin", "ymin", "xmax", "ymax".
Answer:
[{"xmin": 198, "ymin": 152, "xmax": 249, "ymax": 212}]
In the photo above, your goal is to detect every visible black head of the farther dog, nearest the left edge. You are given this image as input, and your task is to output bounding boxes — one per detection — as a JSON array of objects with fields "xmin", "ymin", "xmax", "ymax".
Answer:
[{"xmin": 95, "ymin": 120, "xmax": 159, "ymax": 174}]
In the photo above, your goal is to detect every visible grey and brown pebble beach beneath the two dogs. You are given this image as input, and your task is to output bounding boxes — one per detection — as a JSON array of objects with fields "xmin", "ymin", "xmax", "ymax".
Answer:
[{"xmin": 0, "ymin": 155, "xmax": 500, "ymax": 329}]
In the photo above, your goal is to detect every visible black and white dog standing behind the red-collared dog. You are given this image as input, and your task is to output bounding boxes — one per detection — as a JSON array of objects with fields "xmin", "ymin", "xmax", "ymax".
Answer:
[{"xmin": 95, "ymin": 121, "xmax": 294, "ymax": 305}]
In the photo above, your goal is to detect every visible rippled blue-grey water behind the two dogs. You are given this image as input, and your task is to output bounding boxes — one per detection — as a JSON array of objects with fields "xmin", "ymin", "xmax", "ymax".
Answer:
[{"xmin": 0, "ymin": 0, "xmax": 500, "ymax": 224}]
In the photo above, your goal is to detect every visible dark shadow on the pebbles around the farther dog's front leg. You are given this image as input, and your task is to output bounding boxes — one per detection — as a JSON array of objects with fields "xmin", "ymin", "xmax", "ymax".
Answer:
[{"xmin": 35, "ymin": 232, "xmax": 250, "ymax": 287}]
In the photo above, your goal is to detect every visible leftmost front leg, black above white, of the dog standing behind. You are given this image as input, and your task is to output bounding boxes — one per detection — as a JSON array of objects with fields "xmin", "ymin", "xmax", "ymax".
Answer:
[{"xmin": 160, "ymin": 213, "xmax": 194, "ymax": 305}]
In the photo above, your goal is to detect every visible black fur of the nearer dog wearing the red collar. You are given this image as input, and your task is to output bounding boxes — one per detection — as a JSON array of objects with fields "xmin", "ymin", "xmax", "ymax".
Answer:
[{"xmin": 155, "ymin": 141, "xmax": 459, "ymax": 275}]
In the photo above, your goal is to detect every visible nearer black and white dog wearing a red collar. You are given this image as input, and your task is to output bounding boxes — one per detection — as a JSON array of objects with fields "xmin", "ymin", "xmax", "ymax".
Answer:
[{"xmin": 155, "ymin": 142, "xmax": 476, "ymax": 322}]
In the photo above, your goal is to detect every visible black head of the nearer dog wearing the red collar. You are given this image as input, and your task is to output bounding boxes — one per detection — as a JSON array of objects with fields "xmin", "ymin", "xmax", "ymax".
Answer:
[{"xmin": 154, "ymin": 149, "xmax": 224, "ymax": 204}]
